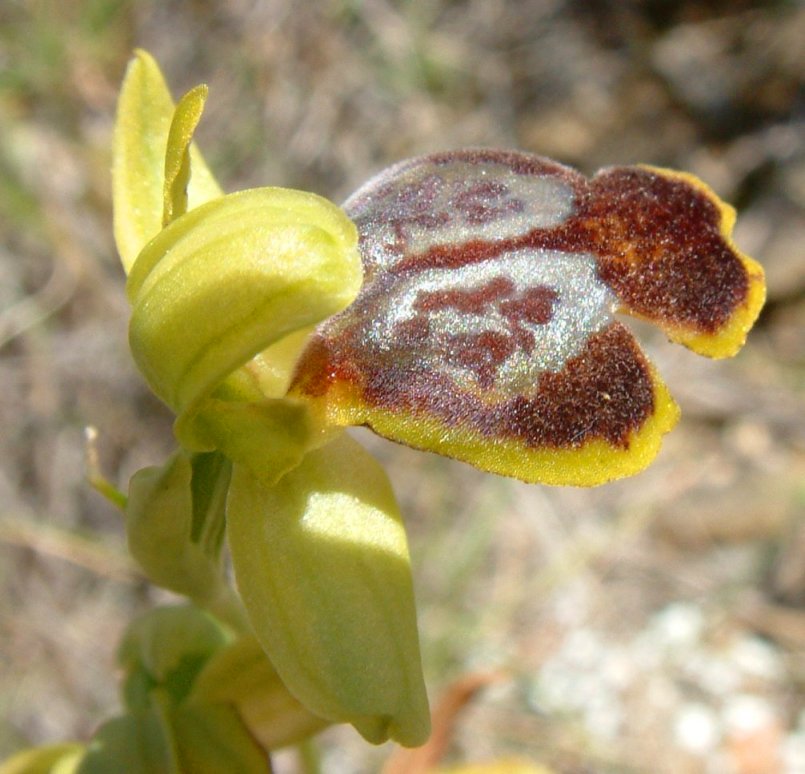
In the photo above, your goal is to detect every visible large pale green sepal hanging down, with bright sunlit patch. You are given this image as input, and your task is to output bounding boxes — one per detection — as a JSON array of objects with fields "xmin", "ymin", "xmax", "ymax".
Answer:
[{"xmin": 227, "ymin": 435, "xmax": 430, "ymax": 746}]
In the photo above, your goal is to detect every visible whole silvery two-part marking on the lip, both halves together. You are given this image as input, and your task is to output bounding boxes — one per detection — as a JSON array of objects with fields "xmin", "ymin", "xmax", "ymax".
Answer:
[{"xmin": 344, "ymin": 151, "xmax": 615, "ymax": 396}]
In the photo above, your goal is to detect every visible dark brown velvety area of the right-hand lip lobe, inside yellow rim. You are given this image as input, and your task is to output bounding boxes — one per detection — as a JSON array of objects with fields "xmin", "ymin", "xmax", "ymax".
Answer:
[{"xmin": 579, "ymin": 167, "xmax": 749, "ymax": 334}]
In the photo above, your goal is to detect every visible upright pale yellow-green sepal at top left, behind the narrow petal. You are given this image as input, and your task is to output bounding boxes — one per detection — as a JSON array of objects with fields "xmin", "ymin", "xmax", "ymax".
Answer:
[{"xmin": 112, "ymin": 51, "xmax": 221, "ymax": 272}]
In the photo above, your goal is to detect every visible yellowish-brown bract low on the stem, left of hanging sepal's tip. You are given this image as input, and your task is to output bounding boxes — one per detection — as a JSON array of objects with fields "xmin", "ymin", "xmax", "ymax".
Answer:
[{"xmin": 189, "ymin": 636, "xmax": 329, "ymax": 750}]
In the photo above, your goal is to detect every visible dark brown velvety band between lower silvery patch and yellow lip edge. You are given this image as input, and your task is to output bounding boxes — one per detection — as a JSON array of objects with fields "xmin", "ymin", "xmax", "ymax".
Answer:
[{"xmin": 295, "ymin": 322, "xmax": 654, "ymax": 448}]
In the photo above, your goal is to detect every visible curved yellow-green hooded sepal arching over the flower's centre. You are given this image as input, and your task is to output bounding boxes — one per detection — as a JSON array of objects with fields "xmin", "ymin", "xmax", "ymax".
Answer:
[{"xmin": 127, "ymin": 188, "xmax": 362, "ymax": 451}]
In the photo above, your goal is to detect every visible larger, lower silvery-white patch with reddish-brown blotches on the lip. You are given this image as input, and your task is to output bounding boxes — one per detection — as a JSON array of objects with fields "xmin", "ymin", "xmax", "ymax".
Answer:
[{"xmin": 365, "ymin": 248, "xmax": 616, "ymax": 395}]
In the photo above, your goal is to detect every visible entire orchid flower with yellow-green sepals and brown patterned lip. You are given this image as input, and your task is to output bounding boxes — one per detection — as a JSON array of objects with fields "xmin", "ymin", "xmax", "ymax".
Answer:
[{"xmin": 108, "ymin": 52, "xmax": 764, "ymax": 756}]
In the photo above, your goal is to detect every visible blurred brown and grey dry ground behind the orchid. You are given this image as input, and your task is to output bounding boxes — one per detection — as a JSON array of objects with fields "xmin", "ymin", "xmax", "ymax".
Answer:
[{"xmin": 0, "ymin": 0, "xmax": 805, "ymax": 774}]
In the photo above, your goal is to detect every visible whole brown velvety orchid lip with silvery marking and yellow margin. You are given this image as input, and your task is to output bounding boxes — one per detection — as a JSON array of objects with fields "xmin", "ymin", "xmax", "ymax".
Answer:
[{"xmin": 291, "ymin": 150, "xmax": 764, "ymax": 485}]
